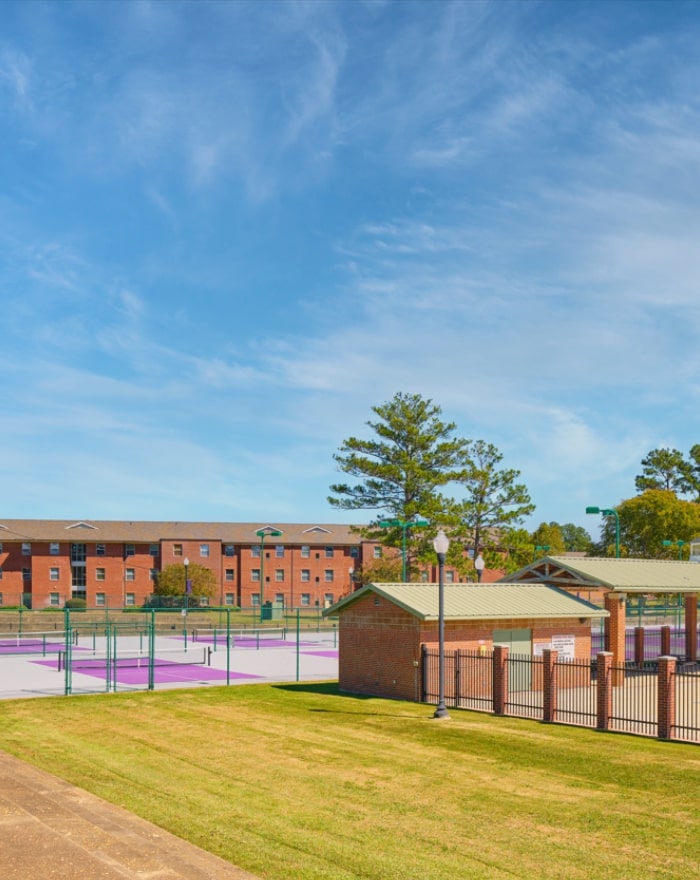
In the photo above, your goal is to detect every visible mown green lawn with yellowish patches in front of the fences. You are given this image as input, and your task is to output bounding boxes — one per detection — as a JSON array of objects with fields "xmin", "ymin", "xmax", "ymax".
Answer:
[{"xmin": 0, "ymin": 684, "xmax": 700, "ymax": 880}]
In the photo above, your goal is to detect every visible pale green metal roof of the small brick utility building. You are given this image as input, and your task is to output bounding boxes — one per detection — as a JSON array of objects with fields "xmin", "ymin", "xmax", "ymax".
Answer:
[{"xmin": 324, "ymin": 583, "xmax": 608, "ymax": 620}]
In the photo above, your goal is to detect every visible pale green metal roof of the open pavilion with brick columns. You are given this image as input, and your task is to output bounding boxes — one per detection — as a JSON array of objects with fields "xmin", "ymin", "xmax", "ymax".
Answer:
[{"xmin": 498, "ymin": 556, "xmax": 700, "ymax": 593}]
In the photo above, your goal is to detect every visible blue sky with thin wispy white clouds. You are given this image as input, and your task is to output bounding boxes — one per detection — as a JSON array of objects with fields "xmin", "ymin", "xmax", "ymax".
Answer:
[{"xmin": 0, "ymin": 0, "xmax": 700, "ymax": 537}]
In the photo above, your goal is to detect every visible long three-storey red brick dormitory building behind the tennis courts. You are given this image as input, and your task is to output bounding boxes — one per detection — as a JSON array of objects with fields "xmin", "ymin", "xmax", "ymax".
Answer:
[{"xmin": 0, "ymin": 519, "xmax": 482, "ymax": 610}]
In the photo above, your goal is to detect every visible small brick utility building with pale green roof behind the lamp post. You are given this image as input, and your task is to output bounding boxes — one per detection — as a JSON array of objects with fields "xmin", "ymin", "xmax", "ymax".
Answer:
[{"xmin": 324, "ymin": 583, "xmax": 608, "ymax": 701}]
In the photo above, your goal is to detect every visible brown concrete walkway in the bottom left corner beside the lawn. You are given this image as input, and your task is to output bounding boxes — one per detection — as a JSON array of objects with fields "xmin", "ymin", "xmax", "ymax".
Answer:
[{"xmin": 0, "ymin": 751, "xmax": 256, "ymax": 880}]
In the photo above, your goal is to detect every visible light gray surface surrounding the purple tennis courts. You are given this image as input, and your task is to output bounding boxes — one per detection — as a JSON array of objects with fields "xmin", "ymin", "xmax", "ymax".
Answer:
[{"xmin": 0, "ymin": 631, "xmax": 338, "ymax": 699}]
